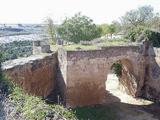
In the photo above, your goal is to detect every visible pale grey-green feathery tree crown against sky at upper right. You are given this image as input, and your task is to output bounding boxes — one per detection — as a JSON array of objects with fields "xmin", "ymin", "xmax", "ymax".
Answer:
[{"xmin": 121, "ymin": 6, "xmax": 154, "ymax": 28}]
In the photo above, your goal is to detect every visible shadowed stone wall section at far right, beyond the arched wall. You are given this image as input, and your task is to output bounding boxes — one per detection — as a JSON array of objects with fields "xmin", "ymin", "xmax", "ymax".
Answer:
[{"xmin": 145, "ymin": 47, "xmax": 160, "ymax": 101}]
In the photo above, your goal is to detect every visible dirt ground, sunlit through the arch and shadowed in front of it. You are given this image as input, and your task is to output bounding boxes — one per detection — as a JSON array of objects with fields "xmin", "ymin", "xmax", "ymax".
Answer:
[{"xmin": 106, "ymin": 74, "xmax": 160, "ymax": 120}]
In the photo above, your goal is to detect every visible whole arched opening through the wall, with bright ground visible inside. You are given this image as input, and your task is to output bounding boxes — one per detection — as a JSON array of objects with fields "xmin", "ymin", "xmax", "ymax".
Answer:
[{"xmin": 105, "ymin": 59, "xmax": 137, "ymax": 101}]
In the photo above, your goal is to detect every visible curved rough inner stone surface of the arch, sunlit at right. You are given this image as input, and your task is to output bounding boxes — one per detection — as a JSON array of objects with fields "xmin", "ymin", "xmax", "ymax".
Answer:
[{"xmin": 105, "ymin": 58, "xmax": 138, "ymax": 97}]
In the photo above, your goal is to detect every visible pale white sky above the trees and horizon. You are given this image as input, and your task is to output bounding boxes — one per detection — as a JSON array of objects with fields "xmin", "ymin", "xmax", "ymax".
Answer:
[{"xmin": 0, "ymin": 0, "xmax": 160, "ymax": 24}]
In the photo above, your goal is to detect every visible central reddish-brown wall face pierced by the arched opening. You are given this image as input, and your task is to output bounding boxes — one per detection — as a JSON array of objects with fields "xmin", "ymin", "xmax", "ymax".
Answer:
[{"xmin": 65, "ymin": 46, "xmax": 141, "ymax": 107}]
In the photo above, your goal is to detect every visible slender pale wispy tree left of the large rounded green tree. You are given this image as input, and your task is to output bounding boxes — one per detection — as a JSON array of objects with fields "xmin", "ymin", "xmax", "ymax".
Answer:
[{"xmin": 45, "ymin": 17, "xmax": 56, "ymax": 44}]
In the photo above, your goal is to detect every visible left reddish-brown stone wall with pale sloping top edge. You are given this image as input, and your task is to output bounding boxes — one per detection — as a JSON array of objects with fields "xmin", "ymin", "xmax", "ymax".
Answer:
[{"xmin": 3, "ymin": 53, "xmax": 57, "ymax": 97}]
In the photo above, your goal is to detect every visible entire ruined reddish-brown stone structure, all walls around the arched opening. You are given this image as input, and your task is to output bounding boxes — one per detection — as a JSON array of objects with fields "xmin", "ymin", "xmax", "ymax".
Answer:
[{"xmin": 4, "ymin": 41, "xmax": 160, "ymax": 107}]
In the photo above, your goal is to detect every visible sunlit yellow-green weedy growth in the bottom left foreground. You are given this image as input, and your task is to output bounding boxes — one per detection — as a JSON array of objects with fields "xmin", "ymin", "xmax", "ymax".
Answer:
[{"xmin": 9, "ymin": 86, "xmax": 76, "ymax": 120}]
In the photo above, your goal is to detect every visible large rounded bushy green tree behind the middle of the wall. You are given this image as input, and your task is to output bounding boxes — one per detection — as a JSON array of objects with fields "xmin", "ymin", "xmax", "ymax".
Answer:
[{"xmin": 58, "ymin": 13, "xmax": 101, "ymax": 43}]
